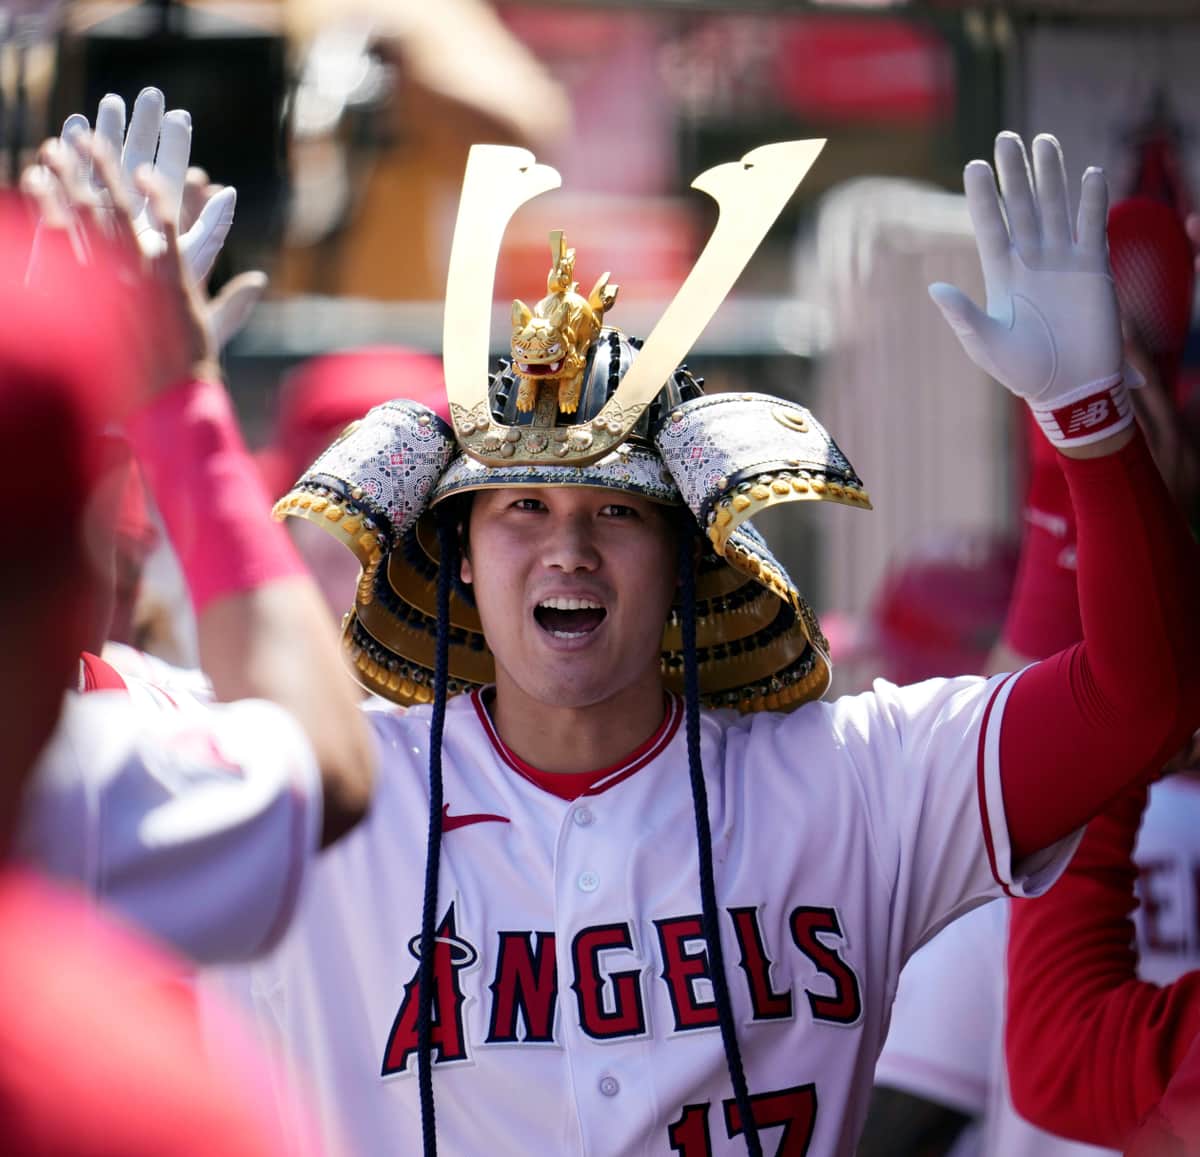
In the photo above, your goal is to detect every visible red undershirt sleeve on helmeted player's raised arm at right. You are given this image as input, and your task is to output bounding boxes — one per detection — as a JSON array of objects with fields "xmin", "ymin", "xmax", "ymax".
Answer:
[{"xmin": 1000, "ymin": 433, "xmax": 1200, "ymax": 858}]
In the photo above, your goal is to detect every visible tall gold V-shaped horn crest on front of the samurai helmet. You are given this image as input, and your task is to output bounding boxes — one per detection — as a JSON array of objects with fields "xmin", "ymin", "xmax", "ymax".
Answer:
[{"xmin": 443, "ymin": 139, "xmax": 824, "ymax": 466}]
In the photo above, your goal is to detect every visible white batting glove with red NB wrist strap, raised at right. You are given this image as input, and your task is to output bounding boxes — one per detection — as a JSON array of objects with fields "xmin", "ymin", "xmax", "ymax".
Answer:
[{"xmin": 929, "ymin": 132, "xmax": 1133, "ymax": 446}]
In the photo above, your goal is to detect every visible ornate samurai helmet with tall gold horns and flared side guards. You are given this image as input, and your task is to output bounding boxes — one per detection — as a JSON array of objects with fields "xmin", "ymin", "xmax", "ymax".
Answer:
[{"xmin": 275, "ymin": 142, "xmax": 870, "ymax": 711}]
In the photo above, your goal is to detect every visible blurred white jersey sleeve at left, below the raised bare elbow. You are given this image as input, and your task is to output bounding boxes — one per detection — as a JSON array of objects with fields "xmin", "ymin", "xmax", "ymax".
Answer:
[{"xmin": 17, "ymin": 693, "xmax": 322, "ymax": 963}]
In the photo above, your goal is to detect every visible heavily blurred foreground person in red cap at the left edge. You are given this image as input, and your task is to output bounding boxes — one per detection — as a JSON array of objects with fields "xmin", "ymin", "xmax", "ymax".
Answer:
[{"xmin": 0, "ymin": 187, "xmax": 333, "ymax": 1157}]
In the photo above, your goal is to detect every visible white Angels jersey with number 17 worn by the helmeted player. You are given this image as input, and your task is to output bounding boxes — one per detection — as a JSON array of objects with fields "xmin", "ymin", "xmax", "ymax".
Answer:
[{"xmin": 204, "ymin": 677, "xmax": 1076, "ymax": 1157}]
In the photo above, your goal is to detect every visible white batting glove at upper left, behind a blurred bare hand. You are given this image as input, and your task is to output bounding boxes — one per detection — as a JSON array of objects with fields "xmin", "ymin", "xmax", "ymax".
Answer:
[{"xmin": 62, "ymin": 88, "xmax": 238, "ymax": 284}]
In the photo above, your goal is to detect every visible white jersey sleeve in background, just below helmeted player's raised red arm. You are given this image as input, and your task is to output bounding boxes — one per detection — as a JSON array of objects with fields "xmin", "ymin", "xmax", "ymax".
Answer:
[{"xmin": 875, "ymin": 900, "xmax": 1008, "ymax": 1117}]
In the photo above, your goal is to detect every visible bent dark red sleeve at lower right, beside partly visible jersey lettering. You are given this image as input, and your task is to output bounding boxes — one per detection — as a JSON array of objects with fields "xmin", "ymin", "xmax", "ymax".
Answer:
[{"xmin": 1004, "ymin": 789, "xmax": 1200, "ymax": 1147}]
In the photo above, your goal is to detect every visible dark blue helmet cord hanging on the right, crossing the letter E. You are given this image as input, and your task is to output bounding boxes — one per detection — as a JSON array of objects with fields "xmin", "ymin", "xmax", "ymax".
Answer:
[{"xmin": 679, "ymin": 532, "xmax": 762, "ymax": 1157}]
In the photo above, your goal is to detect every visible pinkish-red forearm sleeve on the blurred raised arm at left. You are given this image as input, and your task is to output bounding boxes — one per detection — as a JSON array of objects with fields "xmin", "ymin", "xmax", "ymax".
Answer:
[{"xmin": 128, "ymin": 382, "xmax": 306, "ymax": 615}]
